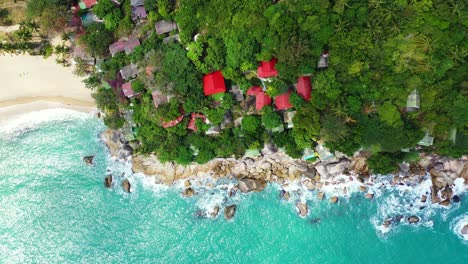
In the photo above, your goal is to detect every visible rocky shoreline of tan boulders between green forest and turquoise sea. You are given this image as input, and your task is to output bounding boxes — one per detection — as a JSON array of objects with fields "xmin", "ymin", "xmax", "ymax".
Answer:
[{"xmin": 101, "ymin": 130, "xmax": 468, "ymax": 226}]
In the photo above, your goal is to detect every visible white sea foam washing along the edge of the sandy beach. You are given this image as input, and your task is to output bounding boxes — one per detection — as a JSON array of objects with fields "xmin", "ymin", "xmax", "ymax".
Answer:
[{"xmin": 0, "ymin": 108, "xmax": 93, "ymax": 139}]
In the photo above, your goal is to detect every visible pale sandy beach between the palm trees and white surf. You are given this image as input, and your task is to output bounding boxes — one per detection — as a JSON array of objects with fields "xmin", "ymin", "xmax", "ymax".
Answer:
[{"xmin": 0, "ymin": 55, "xmax": 96, "ymax": 122}]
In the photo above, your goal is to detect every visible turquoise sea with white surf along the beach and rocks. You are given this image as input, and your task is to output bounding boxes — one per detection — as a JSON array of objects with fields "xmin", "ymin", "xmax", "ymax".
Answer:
[{"xmin": 0, "ymin": 110, "xmax": 468, "ymax": 264}]
